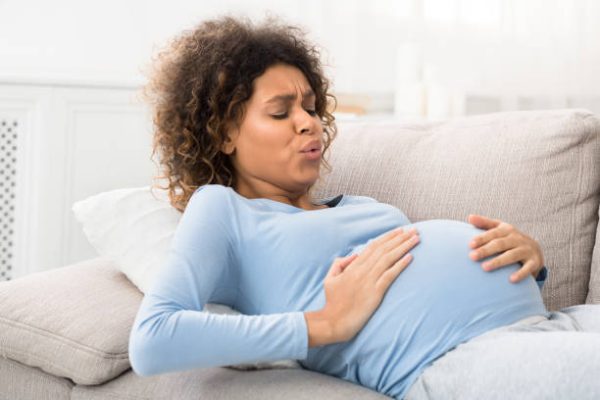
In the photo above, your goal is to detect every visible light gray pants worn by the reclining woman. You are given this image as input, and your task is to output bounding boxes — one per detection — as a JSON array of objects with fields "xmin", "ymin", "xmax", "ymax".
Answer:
[{"xmin": 406, "ymin": 304, "xmax": 600, "ymax": 400}]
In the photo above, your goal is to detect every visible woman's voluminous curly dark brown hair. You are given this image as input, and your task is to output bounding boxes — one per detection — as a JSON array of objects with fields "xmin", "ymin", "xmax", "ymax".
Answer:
[{"xmin": 143, "ymin": 15, "xmax": 337, "ymax": 212}]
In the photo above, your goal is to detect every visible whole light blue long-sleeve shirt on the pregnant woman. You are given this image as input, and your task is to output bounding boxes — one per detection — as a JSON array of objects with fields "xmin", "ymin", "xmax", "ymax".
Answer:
[{"xmin": 129, "ymin": 184, "xmax": 547, "ymax": 398}]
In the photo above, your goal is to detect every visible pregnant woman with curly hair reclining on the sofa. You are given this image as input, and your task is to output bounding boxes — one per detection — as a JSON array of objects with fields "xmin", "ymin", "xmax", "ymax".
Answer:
[{"xmin": 129, "ymin": 17, "xmax": 600, "ymax": 399}]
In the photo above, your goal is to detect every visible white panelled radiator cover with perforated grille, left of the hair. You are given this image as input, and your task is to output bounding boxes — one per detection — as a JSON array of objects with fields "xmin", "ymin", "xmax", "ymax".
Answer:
[{"xmin": 0, "ymin": 79, "xmax": 157, "ymax": 281}]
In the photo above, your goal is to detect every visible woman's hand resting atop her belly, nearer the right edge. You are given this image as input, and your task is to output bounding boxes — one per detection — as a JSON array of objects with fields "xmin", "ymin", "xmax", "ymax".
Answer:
[{"xmin": 467, "ymin": 214, "xmax": 544, "ymax": 283}]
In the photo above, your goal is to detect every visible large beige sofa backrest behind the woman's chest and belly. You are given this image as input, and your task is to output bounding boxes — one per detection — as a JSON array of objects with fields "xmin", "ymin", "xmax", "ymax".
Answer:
[{"xmin": 314, "ymin": 109, "xmax": 600, "ymax": 310}]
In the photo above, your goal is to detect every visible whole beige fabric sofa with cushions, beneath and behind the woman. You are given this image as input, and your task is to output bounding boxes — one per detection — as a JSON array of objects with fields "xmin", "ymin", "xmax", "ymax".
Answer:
[{"xmin": 0, "ymin": 110, "xmax": 600, "ymax": 400}]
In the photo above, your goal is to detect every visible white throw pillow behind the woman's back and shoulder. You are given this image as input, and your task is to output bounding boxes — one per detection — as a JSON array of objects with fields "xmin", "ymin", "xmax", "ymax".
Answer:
[{"xmin": 72, "ymin": 186, "xmax": 301, "ymax": 370}]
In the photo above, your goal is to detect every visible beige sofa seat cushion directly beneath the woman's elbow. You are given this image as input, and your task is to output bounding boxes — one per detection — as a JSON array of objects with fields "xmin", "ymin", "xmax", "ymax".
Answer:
[{"xmin": 71, "ymin": 368, "xmax": 390, "ymax": 400}]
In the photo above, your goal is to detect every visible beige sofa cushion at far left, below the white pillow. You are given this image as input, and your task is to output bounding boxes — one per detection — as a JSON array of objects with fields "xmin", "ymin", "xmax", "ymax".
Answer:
[{"xmin": 0, "ymin": 258, "xmax": 142, "ymax": 385}]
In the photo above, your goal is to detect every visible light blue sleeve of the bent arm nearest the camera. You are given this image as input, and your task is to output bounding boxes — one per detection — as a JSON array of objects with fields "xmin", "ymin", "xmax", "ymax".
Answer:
[{"xmin": 129, "ymin": 186, "xmax": 308, "ymax": 376}]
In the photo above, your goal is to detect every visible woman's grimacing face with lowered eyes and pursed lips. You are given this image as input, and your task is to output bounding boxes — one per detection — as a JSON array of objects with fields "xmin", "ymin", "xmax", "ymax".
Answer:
[{"xmin": 223, "ymin": 64, "xmax": 323, "ymax": 198}]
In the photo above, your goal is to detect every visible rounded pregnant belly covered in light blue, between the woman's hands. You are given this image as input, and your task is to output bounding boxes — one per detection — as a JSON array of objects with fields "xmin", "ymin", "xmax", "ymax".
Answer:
[{"xmin": 308, "ymin": 219, "xmax": 546, "ymax": 393}]
